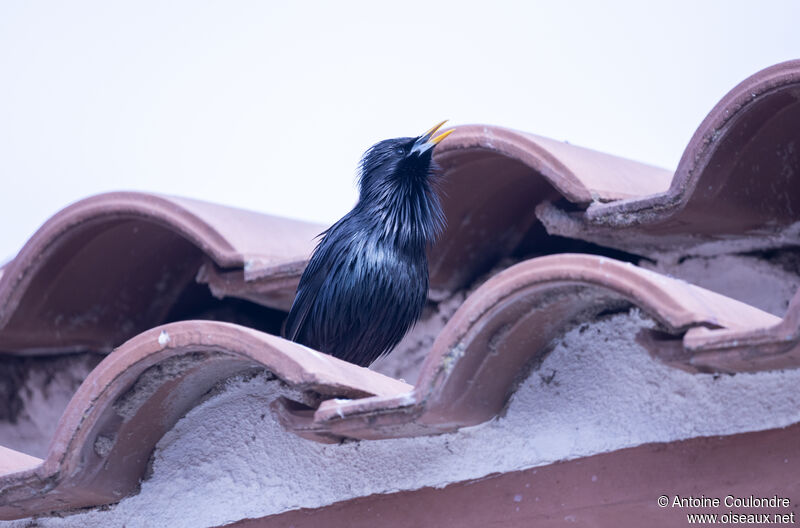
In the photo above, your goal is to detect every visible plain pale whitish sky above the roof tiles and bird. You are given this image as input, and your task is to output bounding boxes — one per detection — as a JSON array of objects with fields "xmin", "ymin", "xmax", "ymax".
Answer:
[{"xmin": 0, "ymin": 0, "xmax": 800, "ymax": 262}]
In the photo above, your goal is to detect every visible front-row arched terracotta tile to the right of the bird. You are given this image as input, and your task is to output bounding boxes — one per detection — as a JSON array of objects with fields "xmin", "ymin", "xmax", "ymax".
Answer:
[{"xmin": 272, "ymin": 254, "xmax": 779, "ymax": 438}]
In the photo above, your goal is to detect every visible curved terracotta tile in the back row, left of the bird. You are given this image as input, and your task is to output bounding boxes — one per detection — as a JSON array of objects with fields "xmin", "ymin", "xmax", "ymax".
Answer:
[{"xmin": 0, "ymin": 192, "xmax": 322, "ymax": 353}]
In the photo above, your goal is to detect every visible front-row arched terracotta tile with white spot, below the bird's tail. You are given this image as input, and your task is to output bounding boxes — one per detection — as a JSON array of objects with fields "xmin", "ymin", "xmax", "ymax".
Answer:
[{"xmin": 0, "ymin": 321, "xmax": 411, "ymax": 519}]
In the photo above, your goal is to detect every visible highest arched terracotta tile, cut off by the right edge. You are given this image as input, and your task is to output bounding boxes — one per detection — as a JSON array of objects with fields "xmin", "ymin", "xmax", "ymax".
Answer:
[{"xmin": 588, "ymin": 60, "xmax": 800, "ymax": 232}]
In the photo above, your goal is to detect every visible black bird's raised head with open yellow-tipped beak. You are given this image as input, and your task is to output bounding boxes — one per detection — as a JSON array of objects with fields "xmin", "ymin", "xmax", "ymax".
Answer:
[{"xmin": 359, "ymin": 121, "xmax": 453, "ymax": 199}]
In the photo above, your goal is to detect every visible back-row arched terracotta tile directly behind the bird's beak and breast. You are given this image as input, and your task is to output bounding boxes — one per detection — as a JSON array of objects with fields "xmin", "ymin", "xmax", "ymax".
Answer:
[{"xmin": 429, "ymin": 125, "xmax": 671, "ymax": 295}]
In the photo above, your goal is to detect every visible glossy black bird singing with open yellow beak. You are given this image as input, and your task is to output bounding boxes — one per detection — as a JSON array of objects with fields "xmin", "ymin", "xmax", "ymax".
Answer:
[{"xmin": 284, "ymin": 121, "xmax": 453, "ymax": 366}]
